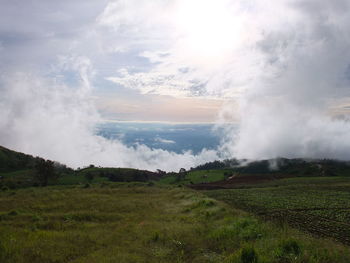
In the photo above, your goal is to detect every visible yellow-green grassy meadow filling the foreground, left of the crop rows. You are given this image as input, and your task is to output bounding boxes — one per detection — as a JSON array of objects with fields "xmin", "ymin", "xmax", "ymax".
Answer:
[{"xmin": 0, "ymin": 183, "xmax": 350, "ymax": 263}]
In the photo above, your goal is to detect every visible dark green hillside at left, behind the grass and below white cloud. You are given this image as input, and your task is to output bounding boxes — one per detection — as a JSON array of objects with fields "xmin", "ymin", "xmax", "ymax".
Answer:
[{"xmin": 0, "ymin": 146, "xmax": 161, "ymax": 189}]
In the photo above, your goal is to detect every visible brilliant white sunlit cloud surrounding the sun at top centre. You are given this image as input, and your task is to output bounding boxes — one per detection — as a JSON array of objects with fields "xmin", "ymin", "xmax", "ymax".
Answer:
[{"xmin": 99, "ymin": 0, "xmax": 254, "ymax": 98}]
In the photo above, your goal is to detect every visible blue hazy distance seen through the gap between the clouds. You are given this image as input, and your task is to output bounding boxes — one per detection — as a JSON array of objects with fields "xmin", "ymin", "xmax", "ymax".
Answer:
[{"xmin": 96, "ymin": 121, "xmax": 231, "ymax": 154}]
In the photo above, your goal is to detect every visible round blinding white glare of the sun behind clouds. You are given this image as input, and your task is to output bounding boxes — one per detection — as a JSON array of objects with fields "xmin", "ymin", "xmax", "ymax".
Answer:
[{"xmin": 176, "ymin": 0, "xmax": 242, "ymax": 59}]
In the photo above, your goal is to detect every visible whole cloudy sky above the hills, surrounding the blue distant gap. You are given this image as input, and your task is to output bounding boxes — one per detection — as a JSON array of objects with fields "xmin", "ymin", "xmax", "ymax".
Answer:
[{"xmin": 0, "ymin": 0, "xmax": 350, "ymax": 170}]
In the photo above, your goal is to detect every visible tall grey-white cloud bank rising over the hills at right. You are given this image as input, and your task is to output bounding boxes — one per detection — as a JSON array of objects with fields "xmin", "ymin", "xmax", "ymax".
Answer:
[{"xmin": 220, "ymin": 1, "xmax": 350, "ymax": 159}]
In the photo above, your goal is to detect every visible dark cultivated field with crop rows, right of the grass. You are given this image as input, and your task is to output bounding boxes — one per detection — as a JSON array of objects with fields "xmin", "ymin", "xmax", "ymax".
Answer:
[{"xmin": 206, "ymin": 177, "xmax": 350, "ymax": 244}]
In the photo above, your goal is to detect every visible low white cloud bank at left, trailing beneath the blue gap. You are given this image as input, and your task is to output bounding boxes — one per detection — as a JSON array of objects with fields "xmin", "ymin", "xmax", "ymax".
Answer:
[{"xmin": 0, "ymin": 69, "xmax": 218, "ymax": 171}]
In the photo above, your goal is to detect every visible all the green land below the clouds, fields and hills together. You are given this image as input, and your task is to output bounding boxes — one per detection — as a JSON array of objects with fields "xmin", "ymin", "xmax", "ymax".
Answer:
[{"xmin": 0, "ymin": 145, "xmax": 350, "ymax": 263}]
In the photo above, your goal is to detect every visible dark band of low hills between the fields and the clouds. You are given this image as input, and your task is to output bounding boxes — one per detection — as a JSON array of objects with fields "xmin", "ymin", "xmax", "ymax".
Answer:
[{"xmin": 0, "ymin": 146, "xmax": 350, "ymax": 192}]
